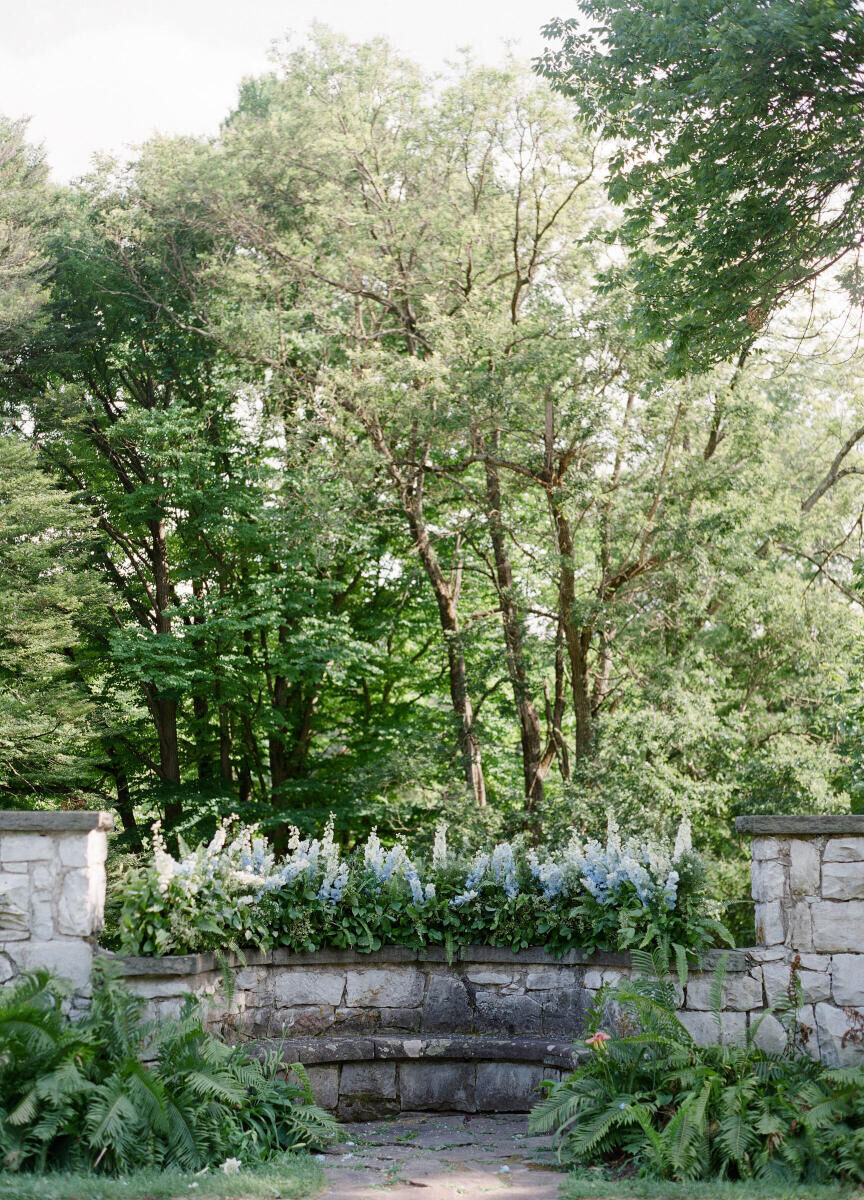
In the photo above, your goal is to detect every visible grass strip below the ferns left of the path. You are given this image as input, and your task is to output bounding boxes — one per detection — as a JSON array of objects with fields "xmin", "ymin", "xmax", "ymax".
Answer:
[{"xmin": 0, "ymin": 1154, "xmax": 322, "ymax": 1200}]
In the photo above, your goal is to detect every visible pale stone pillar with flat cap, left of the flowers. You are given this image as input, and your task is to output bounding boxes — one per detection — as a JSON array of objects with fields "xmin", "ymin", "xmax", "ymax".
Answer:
[{"xmin": 0, "ymin": 812, "xmax": 112, "ymax": 994}]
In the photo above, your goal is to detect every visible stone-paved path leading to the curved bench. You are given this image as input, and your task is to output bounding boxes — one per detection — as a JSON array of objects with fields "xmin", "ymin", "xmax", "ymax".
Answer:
[{"xmin": 322, "ymin": 1112, "xmax": 564, "ymax": 1200}]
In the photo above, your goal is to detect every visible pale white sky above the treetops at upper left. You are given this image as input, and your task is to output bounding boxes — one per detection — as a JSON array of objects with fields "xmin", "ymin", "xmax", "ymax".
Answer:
[{"xmin": 0, "ymin": 0, "xmax": 554, "ymax": 181}]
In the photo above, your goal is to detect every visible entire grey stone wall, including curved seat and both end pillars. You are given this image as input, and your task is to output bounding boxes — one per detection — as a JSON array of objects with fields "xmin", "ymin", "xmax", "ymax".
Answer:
[{"xmin": 0, "ymin": 812, "xmax": 864, "ymax": 1120}]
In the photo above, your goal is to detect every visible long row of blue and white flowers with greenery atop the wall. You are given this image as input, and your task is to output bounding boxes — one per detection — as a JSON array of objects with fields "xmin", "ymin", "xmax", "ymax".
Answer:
[{"xmin": 110, "ymin": 817, "xmax": 731, "ymax": 958}]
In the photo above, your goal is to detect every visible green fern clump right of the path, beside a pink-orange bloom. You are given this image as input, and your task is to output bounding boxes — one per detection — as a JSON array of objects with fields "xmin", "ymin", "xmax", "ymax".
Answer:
[{"xmin": 530, "ymin": 955, "xmax": 864, "ymax": 1183}]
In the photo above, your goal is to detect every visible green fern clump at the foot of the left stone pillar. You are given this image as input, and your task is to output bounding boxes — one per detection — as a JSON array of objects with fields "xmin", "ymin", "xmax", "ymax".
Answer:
[{"xmin": 0, "ymin": 964, "xmax": 338, "ymax": 1174}]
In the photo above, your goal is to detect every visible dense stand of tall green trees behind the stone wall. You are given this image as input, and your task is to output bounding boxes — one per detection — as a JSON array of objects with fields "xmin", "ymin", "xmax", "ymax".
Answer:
[{"xmin": 0, "ymin": 4, "xmax": 864, "ymax": 916}]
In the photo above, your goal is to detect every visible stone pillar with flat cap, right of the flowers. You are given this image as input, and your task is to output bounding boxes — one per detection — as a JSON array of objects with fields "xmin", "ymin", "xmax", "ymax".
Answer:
[{"xmin": 736, "ymin": 815, "xmax": 864, "ymax": 1066}]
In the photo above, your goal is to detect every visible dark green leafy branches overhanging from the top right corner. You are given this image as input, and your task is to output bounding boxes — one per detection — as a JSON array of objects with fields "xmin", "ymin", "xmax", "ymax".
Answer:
[{"xmin": 538, "ymin": 0, "xmax": 864, "ymax": 371}]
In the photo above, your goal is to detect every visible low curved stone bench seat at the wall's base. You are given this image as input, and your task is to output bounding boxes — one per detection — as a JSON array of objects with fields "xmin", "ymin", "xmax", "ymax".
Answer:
[{"xmin": 256, "ymin": 1034, "xmax": 578, "ymax": 1121}]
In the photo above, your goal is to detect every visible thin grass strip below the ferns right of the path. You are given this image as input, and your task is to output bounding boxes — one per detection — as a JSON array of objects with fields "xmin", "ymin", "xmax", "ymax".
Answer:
[{"xmin": 562, "ymin": 1171, "xmax": 864, "ymax": 1200}]
